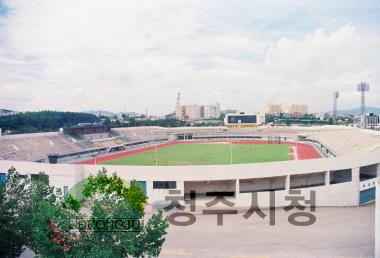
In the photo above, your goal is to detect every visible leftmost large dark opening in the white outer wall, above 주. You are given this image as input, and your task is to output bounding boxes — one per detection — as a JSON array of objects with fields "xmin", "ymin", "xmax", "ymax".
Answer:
[{"xmin": 184, "ymin": 180, "xmax": 236, "ymax": 200}]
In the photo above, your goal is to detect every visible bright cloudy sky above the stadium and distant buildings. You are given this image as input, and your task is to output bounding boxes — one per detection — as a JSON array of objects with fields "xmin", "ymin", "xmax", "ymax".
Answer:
[{"xmin": 0, "ymin": 0, "xmax": 380, "ymax": 115}]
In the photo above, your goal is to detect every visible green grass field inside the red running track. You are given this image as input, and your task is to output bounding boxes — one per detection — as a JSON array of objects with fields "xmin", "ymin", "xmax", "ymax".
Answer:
[{"xmin": 101, "ymin": 143, "xmax": 291, "ymax": 166}]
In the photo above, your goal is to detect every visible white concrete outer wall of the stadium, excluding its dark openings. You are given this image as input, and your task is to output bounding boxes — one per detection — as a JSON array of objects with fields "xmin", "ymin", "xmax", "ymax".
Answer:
[{"xmin": 0, "ymin": 149, "xmax": 380, "ymax": 207}]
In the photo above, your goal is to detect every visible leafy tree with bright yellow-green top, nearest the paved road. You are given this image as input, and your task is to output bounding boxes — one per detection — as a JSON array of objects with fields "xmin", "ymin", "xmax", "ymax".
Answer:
[{"xmin": 80, "ymin": 168, "xmax": 169, "ymax": 257}]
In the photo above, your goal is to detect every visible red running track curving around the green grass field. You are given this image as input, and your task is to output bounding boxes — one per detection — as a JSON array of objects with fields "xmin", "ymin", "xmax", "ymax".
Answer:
[{"xmin": 76, "ymin": 140, "xmax": 321, "ymax": 164}]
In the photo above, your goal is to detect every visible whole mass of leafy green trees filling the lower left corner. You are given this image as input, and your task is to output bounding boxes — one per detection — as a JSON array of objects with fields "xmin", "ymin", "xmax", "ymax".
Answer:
[{"xmin": 0, "ymin": 168, "xmax": 169, "ymax": 257}]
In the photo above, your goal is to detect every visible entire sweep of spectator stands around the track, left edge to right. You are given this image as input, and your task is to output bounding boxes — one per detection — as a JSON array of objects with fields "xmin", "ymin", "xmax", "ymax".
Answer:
[{"xmin": 0, "ymin": 126, "xmax": 380, "ymax": 161}]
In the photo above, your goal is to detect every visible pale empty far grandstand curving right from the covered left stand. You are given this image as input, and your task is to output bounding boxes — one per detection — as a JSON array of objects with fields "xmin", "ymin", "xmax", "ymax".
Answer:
[{"xmin": 113, "ymin": 126, "xmax": 380, "ymax": 156}]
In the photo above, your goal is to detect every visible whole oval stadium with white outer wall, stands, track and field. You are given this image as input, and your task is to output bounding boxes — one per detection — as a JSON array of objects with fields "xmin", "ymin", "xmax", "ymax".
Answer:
[{"xmin": 0, "ymin": 125, "xmax": 380, "ymax": 207}]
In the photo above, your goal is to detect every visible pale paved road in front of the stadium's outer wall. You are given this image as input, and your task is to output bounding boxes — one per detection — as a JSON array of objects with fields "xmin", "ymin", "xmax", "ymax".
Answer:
[{"xmin": 160, "ymin": 205, "xmax": 375, "ymax": 258}]
